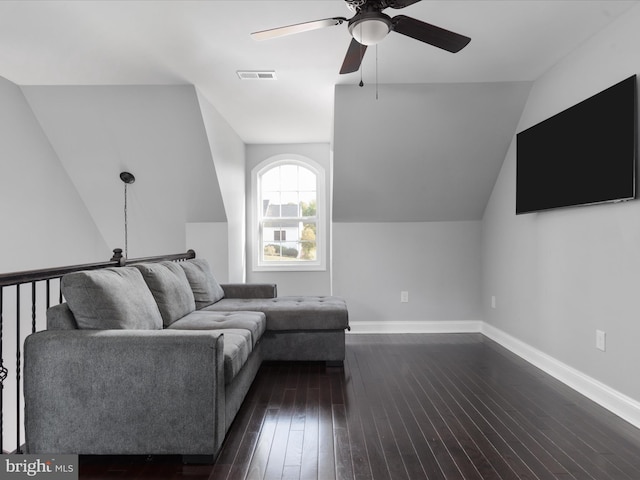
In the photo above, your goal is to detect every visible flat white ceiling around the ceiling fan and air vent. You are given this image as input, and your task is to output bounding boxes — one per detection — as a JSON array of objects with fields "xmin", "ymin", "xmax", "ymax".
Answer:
[{"xmin": 0, "ymin": 0, "xmax": 637, "ymax": 143}]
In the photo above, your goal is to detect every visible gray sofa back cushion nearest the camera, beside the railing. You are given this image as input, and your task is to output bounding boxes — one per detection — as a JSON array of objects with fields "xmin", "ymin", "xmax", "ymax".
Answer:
[{"xmin": 60, "ymin": 267, "xmax": 162, "ymax": 330}]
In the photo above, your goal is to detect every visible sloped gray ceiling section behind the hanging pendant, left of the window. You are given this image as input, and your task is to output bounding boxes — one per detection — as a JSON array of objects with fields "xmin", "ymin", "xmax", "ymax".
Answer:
[{"xmin": 23, "ymin": 86, "xmax": 226, "ymax": 258}]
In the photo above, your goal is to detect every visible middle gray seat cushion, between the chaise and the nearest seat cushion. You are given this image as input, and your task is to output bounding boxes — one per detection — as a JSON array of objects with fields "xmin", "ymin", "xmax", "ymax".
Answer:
[{"xmin": 168, "ymin": 310, "xmax": 267, "ymax": 347}]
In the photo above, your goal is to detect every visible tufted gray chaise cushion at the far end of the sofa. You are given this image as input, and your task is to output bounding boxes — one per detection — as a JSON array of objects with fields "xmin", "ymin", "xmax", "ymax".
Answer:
[{"xmin": 203, "ymin": 296, "xmax": 349, "ymax": 330}]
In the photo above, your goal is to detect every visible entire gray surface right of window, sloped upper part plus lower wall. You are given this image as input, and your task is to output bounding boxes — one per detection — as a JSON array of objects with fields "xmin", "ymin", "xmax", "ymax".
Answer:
[{"xmin": 333, "ymin": 82, "xmax": 510, "ymax": 332}]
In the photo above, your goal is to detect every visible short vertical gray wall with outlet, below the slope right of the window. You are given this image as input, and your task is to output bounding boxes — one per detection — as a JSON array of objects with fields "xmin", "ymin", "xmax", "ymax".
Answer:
[{"xmin": 333, "ymin": 221, "xmax": 482, "ymax": 332}]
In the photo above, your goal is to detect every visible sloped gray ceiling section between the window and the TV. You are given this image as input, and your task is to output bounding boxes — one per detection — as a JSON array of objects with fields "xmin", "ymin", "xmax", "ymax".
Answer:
[{"xmin": 333, "ymin": 82, "xmax": 531, "ymax": 222}]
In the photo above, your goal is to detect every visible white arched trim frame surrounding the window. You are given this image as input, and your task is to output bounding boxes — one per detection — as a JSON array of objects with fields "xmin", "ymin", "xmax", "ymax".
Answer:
[{"xmin": 249, "ymin": 154, "xmax": 327, "ymax": 272}]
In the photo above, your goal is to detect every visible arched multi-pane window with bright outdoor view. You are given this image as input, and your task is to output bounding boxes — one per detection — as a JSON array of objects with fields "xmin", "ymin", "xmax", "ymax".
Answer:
[{"xmin": 252, "ymin": 158, "xmax": 325, "ymax": 270}]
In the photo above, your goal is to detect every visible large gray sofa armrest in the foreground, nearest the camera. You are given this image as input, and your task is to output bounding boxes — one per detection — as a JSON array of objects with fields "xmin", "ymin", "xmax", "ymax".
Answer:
[{"xmin": 24, "ymin": 330, "xmax": 225, "ymax": 455}]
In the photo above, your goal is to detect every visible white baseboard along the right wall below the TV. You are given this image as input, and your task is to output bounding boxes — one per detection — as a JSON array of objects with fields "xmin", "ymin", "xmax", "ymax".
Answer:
[{"xmin": 482, "ymin": 322, "xmax": 640, "ymax": 428}]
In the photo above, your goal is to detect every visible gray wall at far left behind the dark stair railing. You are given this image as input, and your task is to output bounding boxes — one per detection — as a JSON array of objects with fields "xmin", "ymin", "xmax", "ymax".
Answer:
[{"xmin": 0, "ymin": 77, "xmax": 112, "ymax": 451}]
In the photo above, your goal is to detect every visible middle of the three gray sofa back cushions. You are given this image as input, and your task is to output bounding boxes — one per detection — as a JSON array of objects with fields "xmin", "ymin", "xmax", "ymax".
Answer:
[{"xmin": 132, "ymin": 262, "xmax": 196, "ymax": 327}]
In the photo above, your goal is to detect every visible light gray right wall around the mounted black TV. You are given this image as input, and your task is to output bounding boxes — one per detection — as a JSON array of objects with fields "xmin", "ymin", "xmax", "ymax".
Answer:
[{"xmin": 482, "ymin": 3, "xmax": 640, "ymax": 400}]
